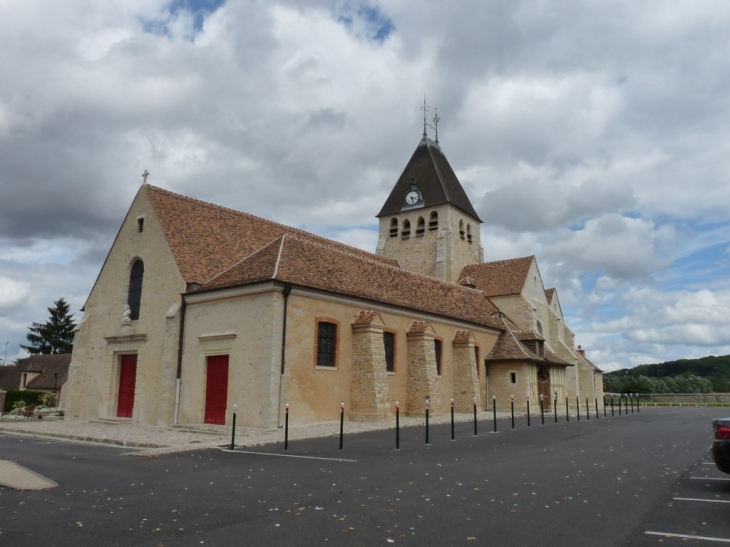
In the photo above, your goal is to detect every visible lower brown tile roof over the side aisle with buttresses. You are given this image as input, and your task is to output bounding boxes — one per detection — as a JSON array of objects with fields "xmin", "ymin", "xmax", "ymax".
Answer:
[{"xmin": 200, "ymin": 234, "xmax": 500, "ymax": 328}]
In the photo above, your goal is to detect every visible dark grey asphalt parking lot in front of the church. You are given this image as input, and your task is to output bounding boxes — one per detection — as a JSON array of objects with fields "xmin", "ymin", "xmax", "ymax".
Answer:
[{"xmin": 0, "ymin": 408, "xmax": 730, "ymax": 547}]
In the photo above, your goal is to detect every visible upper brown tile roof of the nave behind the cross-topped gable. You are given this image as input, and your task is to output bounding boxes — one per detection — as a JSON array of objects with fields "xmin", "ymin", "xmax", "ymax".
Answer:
[{"xmin": 144, "ymin": 185, "xmax": 397, "ymax": 285}]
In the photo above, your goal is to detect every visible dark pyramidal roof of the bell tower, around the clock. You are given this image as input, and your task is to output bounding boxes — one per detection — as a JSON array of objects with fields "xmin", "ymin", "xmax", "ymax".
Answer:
[{"xmin": 377, "ymin": 137, "xmax": 481, "ymax": 222}]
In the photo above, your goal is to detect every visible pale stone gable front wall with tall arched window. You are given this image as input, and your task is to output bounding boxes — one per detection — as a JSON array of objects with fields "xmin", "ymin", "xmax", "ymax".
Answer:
[{"xmin": 64, "ymin": 188, "xmax": 185, "ymax": 424}]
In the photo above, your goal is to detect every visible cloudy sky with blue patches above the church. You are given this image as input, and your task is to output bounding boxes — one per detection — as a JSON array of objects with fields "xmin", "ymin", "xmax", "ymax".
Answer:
[{"xmin": 0, "ymin": 0, "xmax": 730, "ymax": 370}]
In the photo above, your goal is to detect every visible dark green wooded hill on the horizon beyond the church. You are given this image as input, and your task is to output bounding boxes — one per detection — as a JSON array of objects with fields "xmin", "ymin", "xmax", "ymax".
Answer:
[{"xmin": 603, "ymin": 355, "xmax": 730, "ymax": 393}]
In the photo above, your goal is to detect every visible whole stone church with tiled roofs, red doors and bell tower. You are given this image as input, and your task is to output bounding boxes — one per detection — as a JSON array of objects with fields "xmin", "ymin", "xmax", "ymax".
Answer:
[{"xmin": 64, "ymin": 131, "xmax": 603, "ymax": 428}]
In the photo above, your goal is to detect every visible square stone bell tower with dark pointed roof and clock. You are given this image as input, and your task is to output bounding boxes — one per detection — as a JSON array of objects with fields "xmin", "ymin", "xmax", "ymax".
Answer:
[{"xmin": 375, "ymin": 133, "xmax": 484, "ymax": 283}]
